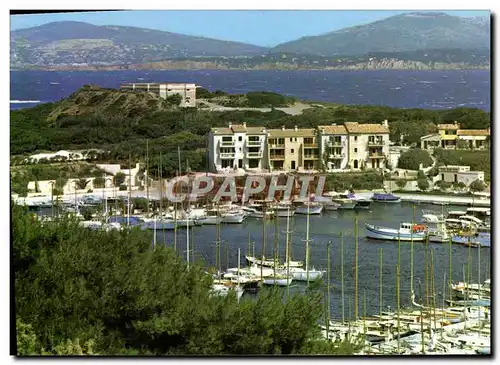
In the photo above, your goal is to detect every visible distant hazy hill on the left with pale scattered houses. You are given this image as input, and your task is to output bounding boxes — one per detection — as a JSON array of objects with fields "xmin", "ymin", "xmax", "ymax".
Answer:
[{"xmin": 10, "ymin": 22, "xmax": 267, "ymax": 67}]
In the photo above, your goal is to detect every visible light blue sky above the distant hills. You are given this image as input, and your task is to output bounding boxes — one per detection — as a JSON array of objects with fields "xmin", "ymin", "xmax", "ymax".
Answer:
[{"xmin": 10, "ymin": 10, "xmax": 489, "ymax": 46}]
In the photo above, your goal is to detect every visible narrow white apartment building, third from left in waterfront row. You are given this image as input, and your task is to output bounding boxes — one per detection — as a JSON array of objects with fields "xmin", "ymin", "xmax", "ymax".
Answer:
[{"xmin": 318, "ymin": 124, "xmax": 349, "ymax": 171}]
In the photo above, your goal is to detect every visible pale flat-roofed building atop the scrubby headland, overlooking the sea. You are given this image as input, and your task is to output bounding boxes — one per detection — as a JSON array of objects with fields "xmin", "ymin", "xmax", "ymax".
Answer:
[{"xmin": 120, "ymin": 82, "xmax": 196, "ymax": 107}]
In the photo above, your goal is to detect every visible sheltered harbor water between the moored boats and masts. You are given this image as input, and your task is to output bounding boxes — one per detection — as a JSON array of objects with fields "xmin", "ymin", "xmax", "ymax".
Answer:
[{"xmin": 150, "ymin": 202, "xmax": 491, "ymax": 319}]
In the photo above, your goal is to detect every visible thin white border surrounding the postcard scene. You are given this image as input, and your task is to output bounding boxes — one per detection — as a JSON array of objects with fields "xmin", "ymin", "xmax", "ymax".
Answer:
[{"xmin": 0, "ymin": 0, "xmax": 500, "ymax": 364}]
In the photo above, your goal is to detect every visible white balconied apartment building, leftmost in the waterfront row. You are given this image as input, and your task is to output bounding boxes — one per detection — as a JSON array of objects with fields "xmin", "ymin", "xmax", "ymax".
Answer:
[{"xmin": 208, "ymin": 123, "xmax": 267, "ymax": 172}]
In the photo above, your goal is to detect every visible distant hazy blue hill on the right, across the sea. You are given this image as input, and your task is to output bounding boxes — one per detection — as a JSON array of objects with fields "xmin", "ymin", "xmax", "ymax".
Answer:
[{"xmin": 271, "ymin": 13, "xmax": 490, "ymax": 56}]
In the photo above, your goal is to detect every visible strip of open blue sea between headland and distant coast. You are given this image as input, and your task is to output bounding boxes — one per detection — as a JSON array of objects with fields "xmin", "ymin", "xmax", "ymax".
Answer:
[{"xmin": 10, "ymin": 70, "xmax": 491, "ymax": 111}]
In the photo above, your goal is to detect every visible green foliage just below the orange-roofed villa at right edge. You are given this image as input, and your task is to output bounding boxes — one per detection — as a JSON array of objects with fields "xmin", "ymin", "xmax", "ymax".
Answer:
[{"xmin": 434, "ymin": 148, "xmax": 491, "ymax": 181}]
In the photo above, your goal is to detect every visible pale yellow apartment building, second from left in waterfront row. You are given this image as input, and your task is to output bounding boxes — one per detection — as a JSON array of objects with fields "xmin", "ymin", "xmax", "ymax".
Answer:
[{"xmin": 267, "ymin": 126, "xmax": 320, "ymax": 171}]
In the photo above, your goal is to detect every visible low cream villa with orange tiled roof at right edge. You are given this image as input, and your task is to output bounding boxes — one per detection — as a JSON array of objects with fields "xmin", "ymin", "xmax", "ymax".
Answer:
[{"xmin": 420, "ymin": 122, "xmax": 490, "ymax": 151}]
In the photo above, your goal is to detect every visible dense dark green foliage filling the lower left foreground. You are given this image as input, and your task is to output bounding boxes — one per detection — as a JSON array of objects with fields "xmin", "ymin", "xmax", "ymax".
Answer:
[{"xmin": 12, "ymin": 205, "xmax": 356, "ymax": 355}]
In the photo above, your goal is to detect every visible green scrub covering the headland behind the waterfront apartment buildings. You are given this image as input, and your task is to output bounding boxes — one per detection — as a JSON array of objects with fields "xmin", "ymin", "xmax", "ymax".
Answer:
[{"xmin": 11, "ymin": 89, "xmax": 490, "ymax": 181}]
